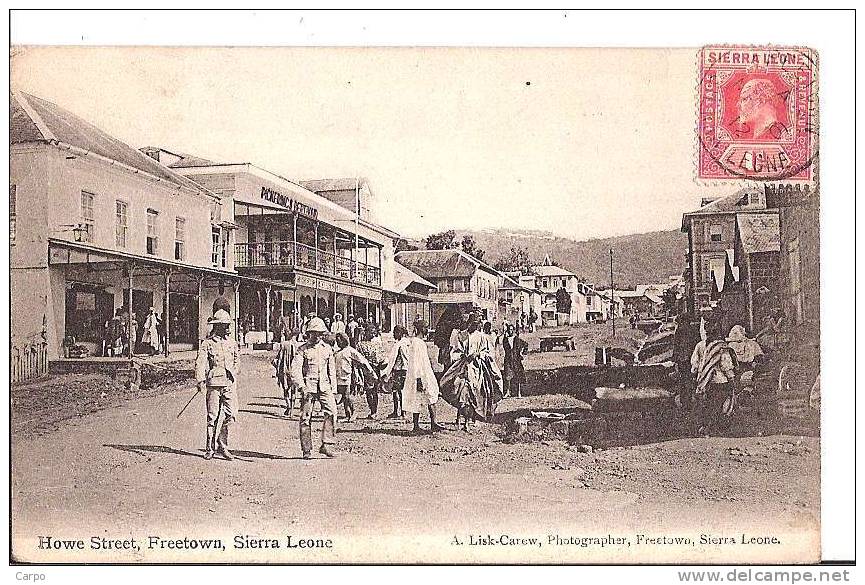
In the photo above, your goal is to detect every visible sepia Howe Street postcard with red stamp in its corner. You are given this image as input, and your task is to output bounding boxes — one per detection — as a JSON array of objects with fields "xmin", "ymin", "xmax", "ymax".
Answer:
[{"xmin": 9, "ymin": 43, "xmax": 821, "ymax": 564}]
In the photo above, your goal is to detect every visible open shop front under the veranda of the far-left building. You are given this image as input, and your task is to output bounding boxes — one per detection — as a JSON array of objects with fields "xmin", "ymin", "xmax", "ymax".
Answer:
[{"xmin": 46, "ymin": 240, "xmax": 280, "ymax": 359}]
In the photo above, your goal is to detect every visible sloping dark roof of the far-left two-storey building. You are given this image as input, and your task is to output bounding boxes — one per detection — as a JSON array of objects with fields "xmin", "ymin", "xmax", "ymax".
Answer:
[{"xmin": 10, "ymin": 92, "xmax": 206, "ymax": 192}]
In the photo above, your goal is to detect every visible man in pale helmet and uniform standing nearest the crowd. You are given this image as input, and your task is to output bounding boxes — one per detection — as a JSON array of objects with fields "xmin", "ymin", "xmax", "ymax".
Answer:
[{"xmin": 291, "ymin": 317, "xmax": 336, "ymax": 459}]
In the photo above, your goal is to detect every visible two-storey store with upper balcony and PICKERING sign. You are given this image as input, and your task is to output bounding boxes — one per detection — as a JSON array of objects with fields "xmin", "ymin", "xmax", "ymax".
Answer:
[{"xmin": 145, "ymin": 148, "xmax": 399, "ymax": 341}]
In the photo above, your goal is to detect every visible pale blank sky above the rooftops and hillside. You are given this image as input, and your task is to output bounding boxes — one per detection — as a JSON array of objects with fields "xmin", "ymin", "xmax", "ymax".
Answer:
[{"xmin": 11, "ymin": 47, "xmax": 733, "ymax": 240}]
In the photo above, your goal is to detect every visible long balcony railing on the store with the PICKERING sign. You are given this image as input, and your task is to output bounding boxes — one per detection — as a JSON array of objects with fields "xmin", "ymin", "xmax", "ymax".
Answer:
[{"xmin": 234, "ymin": 241, "xmax": 381, "ymax": 286}]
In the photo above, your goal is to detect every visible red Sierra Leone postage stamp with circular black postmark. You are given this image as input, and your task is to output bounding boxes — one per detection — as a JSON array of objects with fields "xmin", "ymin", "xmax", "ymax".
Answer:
[{"xmin": 697, "ymin": 46, "xmax": 818, "ymax": 181}]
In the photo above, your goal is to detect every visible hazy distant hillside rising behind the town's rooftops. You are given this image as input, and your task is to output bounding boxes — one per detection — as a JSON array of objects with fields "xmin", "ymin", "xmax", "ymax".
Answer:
[{"xmin": 402, "ymin": 229, "xmax": 688, "ymax": 288}]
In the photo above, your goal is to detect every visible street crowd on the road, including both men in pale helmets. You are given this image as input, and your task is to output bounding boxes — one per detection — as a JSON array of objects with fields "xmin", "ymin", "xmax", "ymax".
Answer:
[{"xmin": 196, "ymin": 306, "xmax": 527, "ymax": 460}]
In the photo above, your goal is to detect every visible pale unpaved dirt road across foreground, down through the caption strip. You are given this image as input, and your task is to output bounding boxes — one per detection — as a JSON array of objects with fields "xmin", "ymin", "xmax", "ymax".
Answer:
[{"xmin": 12, "ymin": 356, "xmax": 820, "ymax": 563}]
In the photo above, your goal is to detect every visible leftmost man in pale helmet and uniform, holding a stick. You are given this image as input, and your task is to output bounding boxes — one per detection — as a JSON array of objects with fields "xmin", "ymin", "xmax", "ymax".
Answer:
[{"xmin": 195, "ymin": 309, "xmax": 240, "ymax": 461}]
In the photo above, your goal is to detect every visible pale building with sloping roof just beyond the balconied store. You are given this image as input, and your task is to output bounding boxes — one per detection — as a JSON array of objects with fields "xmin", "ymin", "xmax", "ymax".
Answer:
[{"xmin": 396, "ymin": 250, "xmax": 502, "ymax": 324}]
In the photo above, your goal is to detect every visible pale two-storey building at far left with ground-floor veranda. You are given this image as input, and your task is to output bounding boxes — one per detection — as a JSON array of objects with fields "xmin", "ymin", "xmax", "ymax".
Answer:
[{"xmin": 9, "ymin": 92, "xmax": 267, "ymax": 359}]
